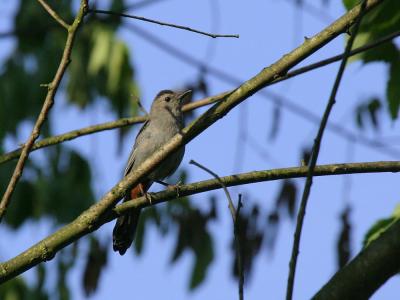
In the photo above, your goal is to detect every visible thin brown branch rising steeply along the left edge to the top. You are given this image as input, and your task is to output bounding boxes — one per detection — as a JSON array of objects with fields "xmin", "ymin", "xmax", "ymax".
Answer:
[{"xmin": 0, "ymin": 0, "xmax": 87, "ymax": 222}]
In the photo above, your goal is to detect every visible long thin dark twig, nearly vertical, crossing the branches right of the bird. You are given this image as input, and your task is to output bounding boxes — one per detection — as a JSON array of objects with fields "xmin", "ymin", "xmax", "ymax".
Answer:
[{"xmin": 286, "ymin": 1, "xmax": 367, "ymax": 300}]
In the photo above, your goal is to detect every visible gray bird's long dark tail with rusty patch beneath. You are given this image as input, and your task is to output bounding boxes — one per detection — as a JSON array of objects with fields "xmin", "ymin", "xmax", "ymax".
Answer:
[{"xmin": 113, "ymin": 183, "xmax": 151, "ymax": 255}]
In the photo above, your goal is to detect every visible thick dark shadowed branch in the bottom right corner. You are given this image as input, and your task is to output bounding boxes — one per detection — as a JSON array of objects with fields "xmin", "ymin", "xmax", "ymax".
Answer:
[{"xmin": 312, "ymin": 220, "xmax": 400, "ymax": 300}]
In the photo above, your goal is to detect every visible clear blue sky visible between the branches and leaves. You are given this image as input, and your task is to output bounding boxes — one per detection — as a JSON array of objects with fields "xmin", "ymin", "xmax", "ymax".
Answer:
[{"xmin": 0, "ymin": 0, "xmax": 400, "ymax": 300}]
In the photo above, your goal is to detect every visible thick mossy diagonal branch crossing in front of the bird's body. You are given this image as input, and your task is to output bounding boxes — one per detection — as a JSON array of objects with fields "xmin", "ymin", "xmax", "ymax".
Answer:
[{"xmin": 0, "ymin": 0, "xmax": 383, "ymax": 281}]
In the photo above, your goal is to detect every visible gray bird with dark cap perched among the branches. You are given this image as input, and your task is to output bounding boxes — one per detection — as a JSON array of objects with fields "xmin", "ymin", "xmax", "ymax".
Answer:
[{"xmin": 113, "ymin": 90, "xmax": 191, "ymax": 255}]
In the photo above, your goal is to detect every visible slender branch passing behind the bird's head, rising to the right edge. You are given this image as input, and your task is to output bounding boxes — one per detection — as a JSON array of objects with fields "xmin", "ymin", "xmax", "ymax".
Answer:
[{"xmin": 0, "ymin": 26, "xmax": 400, "ymax": 164}]
